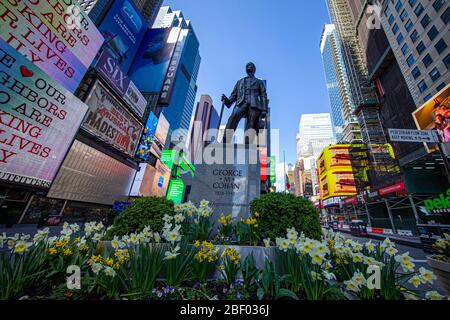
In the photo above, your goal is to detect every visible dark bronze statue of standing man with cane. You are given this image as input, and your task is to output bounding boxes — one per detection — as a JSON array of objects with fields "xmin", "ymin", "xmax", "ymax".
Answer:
[{"xmin": 222, "ymin": 62, "xmax": 268, "ymax": 143}]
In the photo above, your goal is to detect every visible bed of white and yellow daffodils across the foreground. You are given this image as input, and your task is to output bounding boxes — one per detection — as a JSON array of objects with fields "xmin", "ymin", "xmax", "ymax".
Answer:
[{"xmin": 0, "ymin": 201, "xmax": 444, "ymax": 300}]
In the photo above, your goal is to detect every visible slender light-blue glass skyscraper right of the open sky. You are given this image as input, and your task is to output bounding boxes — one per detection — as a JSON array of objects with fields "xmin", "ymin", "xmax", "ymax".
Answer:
[{"xmin": 320, "ymin": 24, "xmax": 360, "ymax": 143}]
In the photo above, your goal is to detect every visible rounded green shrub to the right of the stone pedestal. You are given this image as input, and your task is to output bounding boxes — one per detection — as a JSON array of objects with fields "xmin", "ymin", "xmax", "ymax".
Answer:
[{"xmin": 250, "ymin": 193, "xmax": 321, "ymax": 240}]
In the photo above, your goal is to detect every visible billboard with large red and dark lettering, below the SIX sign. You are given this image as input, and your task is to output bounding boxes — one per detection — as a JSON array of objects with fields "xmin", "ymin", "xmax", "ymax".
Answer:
[{"xmin": 82, "ymin": 81, "xmax": 143, "ymax": 157}]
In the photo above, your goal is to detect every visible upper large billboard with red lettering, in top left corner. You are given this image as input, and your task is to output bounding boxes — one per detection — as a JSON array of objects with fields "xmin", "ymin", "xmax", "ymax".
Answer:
[{"xmin": 0, "ymin": 0, "xmax": 104, "ymax": 92}]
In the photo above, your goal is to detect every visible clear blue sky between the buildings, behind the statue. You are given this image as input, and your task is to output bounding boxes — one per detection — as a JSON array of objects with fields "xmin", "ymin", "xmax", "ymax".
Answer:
[{"xmin": 164, "ymin": 0, "xmax": 330, "ymax": 168}]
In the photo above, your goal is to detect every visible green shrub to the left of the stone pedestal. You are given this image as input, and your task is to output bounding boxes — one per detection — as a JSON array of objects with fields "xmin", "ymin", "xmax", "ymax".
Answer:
[{"xmin": 108, "ymin": 197, "xmax": 174, "ymax": 237}]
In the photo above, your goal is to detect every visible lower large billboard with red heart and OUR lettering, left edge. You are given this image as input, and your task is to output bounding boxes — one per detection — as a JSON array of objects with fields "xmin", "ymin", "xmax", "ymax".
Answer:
[{"xmin": 0, "ymin": 39, "xmax": 88, "ymax": 188}]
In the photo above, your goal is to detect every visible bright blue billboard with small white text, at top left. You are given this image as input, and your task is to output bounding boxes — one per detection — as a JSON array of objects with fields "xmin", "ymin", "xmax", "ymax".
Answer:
[{"xmin": 99, "ymin": 0, "xmax": 148, "ymax": 76}]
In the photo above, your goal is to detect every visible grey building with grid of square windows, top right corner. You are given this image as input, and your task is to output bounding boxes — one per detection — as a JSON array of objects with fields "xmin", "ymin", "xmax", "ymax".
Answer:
[{"xmin": 381, "ymin": 0, "xmax": 450, "ymax": 107}]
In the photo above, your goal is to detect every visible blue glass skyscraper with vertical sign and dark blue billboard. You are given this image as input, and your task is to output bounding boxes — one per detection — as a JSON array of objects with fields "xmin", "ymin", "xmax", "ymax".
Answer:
[{"xmin": 130, "ymin": 6, "xmax": 201, "ymax": 137}]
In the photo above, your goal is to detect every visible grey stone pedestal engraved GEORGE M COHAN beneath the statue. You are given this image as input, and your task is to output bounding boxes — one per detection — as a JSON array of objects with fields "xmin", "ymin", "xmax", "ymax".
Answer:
[{"xmin": 183, "ymin": 144, "xmax": 261, "ymax": 222}]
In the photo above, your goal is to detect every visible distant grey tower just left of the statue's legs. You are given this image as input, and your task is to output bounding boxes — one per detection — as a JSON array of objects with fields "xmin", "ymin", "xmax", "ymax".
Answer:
[{"xmin": 189, "ymin": 94, "xmax": 219, "ymax": 163}]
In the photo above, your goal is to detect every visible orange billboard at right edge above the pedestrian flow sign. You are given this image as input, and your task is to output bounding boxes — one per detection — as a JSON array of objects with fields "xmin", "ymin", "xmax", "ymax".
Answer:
[{"xmin": 412, "ymin": 84, "xmax": 450, "ymax": 152}]
